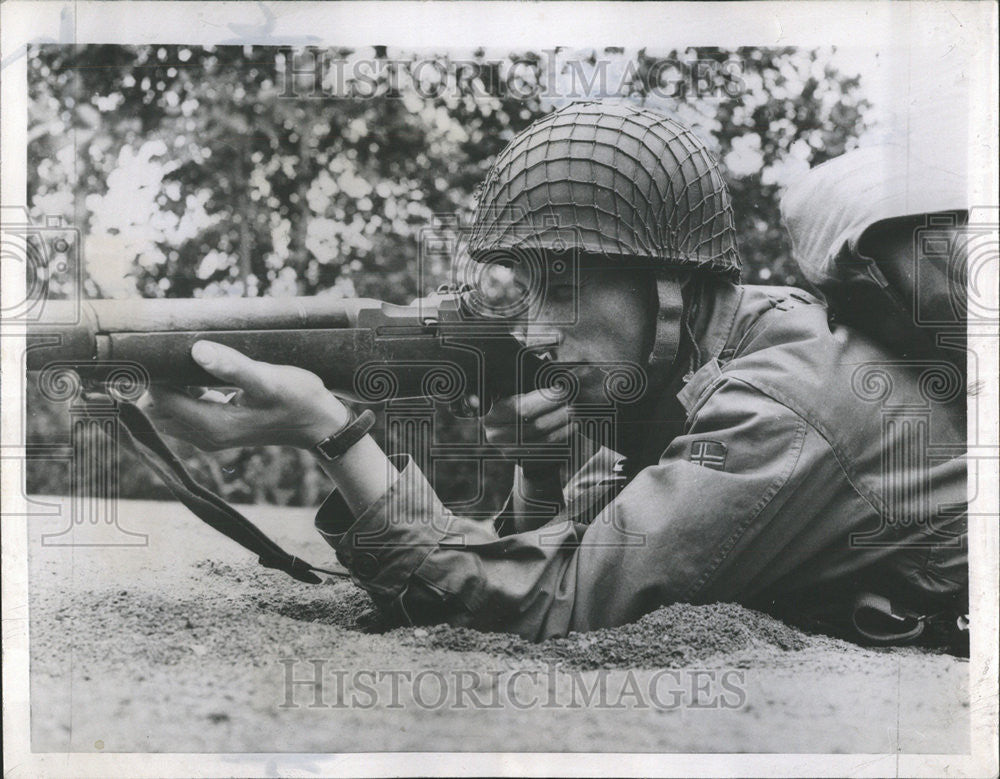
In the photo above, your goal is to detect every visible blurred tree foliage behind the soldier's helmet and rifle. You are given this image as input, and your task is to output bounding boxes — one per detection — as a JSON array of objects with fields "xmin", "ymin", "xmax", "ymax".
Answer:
[{"xmin": 27, "ymin": 45, "xmax": 870, "ymax": 505}]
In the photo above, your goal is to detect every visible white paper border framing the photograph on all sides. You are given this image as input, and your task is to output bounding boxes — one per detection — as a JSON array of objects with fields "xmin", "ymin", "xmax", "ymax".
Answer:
[{"xmin": 0, "ymin": 0, "xmax": 1000, "ymax": 777}]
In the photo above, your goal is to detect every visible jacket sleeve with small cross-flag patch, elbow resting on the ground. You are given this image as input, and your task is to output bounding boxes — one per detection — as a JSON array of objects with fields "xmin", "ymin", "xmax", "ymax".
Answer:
[{"xmin": 316, "ymin": 377, "xmax": 834, "ymax": 640}]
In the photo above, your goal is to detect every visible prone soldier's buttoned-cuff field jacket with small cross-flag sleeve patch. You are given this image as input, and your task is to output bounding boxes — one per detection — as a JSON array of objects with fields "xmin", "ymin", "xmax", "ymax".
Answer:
[{"xmin": 316, "ymin": 283, "xmax": 968, "ymax": 640}]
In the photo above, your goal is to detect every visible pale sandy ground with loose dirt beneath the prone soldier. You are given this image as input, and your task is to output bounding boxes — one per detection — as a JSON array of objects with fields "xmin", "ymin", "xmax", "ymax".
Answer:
[{"xmin": 28, "ymin": 499, "xmax": 969, "ymax": 753}]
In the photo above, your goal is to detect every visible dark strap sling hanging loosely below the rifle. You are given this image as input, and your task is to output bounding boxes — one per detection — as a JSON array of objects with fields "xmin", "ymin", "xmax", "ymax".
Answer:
[{"xmin": 112, "ymin": 402, "xmax": 348, "ymax": 584}]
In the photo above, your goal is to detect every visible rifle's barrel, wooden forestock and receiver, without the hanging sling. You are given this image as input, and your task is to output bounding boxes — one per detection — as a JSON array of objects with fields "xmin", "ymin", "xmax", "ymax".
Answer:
[{"xmin": 27, "ymin": 297, "xmax": 540, "ymax": 411}]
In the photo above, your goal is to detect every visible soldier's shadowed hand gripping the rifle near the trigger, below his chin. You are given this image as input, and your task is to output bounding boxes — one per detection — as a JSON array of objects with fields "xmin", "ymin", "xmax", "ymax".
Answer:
[{"xmin": 482, "ymin": 390, "xmax": 570, "ymax": 450}]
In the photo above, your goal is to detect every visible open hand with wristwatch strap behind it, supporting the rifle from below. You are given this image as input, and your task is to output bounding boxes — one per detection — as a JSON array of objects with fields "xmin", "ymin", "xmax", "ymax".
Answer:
[{"xmin": 141, "ymin": 341, "xmax": 350, "ymax": 451}]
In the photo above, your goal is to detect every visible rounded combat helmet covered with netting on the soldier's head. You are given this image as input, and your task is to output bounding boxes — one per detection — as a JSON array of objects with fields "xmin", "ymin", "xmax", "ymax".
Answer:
[{"xmin": 467, "ymin": 102, "xmax": 740, "ymax": 279}]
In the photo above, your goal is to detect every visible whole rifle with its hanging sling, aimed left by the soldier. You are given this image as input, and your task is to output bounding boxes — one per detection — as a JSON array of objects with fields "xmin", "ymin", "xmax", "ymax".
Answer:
[{"xmin": 27, "ymin": 290, "xmax": 546, "ymax": 583}]
